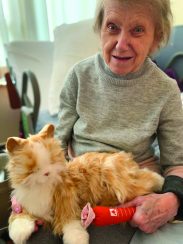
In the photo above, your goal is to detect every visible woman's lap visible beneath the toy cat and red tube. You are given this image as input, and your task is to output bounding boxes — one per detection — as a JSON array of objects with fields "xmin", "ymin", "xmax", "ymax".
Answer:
[{"xmin": 27, "ymin": 223, "xmax": 183, "ymax": 244}]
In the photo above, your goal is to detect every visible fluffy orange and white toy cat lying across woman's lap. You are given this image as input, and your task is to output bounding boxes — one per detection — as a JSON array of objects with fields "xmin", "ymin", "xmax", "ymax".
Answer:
[{"xmin": 6, "ymin": 124, "xmax": 164, "ymax": 244}]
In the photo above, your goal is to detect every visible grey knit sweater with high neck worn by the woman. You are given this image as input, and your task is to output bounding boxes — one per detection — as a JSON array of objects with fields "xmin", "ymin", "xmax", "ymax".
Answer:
[{"xmin": 57, "ymin": 54, "xmax": 183, "ymax": 166}]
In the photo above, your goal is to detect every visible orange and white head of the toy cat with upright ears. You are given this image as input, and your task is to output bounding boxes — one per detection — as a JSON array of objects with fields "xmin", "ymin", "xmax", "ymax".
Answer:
[{"xmin": 6, "ymin": 124, "xmax": 65, "ymax": 188}]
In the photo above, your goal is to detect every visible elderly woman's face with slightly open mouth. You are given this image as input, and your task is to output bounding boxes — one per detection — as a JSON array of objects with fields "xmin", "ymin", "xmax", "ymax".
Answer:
[{"xmin": 101, "ymin": 1, "xmax": 157, "ymax": 75}]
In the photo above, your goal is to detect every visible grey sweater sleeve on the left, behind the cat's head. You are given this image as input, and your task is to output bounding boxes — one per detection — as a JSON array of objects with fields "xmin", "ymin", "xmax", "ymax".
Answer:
[{"xmin": 56, "ymin": 68, "xmax": 78, "ymax": 149}]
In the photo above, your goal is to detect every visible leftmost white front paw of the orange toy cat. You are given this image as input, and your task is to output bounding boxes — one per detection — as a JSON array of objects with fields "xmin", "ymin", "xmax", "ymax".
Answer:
[{"xmin": 9, "ymin": 218, "xmax": 35, "ymax": 244}]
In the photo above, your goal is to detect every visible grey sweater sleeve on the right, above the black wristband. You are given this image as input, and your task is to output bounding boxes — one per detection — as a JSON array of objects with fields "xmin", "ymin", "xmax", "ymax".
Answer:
[{"xmin": 157, "ymin": 84, "xmax": 183, "ymax": 169}]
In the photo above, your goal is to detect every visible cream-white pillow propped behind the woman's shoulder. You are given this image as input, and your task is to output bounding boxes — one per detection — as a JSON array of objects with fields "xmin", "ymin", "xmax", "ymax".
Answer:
[{"xmin": 48, "ymin": 19, "xmax": 99, "ymax": 115}]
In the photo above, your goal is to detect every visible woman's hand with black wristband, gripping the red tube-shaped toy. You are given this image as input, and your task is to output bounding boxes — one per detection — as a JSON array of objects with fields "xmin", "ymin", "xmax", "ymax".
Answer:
[{"xmin": 122, "ymin": 192, "xmax": 179, "ymax": 233}]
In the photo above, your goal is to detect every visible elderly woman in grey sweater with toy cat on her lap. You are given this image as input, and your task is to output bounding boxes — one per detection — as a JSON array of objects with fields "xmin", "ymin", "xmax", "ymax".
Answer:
[{"xmin": 28, "ymin": 0, "xmax": 183, "ymax": 244}]
